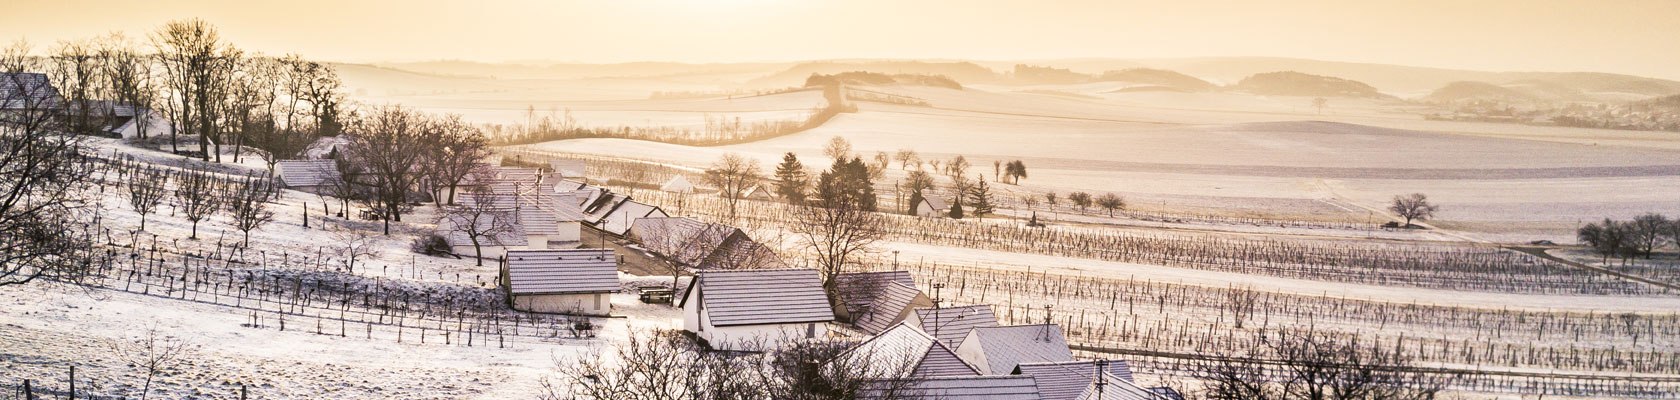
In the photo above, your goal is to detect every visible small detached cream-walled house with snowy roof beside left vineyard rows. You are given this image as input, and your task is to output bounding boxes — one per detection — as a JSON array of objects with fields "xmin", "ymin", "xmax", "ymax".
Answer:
[{"xmin": 502, "ymin": 249, "xmax": 618, "ymax": 316}]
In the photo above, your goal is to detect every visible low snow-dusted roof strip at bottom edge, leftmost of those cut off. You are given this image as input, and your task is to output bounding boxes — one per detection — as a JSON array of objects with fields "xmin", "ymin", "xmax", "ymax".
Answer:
[{"xmin": 857, "ymin": 375, "xmax": 1042, "ymax": 400}]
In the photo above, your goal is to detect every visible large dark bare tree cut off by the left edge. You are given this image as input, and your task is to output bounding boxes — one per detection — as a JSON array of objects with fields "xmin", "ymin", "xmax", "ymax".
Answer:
[{"xmin": 0, "ymin": 42, "xmax": 94, "ymax": 286}]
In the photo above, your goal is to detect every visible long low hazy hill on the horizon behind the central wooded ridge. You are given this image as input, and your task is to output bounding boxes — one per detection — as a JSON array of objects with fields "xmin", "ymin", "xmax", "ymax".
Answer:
[{"xmin": 746, "ymin": 61, "xmax": 1001, "ymax": 87}]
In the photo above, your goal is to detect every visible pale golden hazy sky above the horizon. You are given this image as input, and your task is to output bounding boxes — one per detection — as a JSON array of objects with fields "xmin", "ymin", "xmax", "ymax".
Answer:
[{"xmin": 0, "ymin": 0, "xmax": 1680, "ymax": 79}]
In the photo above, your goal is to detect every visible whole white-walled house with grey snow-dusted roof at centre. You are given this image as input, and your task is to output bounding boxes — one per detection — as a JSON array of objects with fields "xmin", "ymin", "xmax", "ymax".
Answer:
[{"xmin": 677, "ymin": 269, "xmax": 835, "ymax": 351}]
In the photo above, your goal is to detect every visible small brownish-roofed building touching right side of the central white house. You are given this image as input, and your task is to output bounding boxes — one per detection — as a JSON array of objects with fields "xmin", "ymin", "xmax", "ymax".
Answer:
[{"xmin": 833, "ymin": 271, "xmax": 934, "ymax": 333}]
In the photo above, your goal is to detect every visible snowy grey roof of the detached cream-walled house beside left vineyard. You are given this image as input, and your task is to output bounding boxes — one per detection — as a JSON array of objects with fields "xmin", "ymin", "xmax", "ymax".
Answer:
[{"xmin": 507, "ymin": 249, "xmax": 618, "ymax": 294}]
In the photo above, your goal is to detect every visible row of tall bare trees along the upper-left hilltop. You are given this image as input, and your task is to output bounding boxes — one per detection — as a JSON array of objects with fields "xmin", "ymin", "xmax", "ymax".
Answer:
[{"xmin": 0, "ymin": 18, "xmax": 348, "ymax": 166}]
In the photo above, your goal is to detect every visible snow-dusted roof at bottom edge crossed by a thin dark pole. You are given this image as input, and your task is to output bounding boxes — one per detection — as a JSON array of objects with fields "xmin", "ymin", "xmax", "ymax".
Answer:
[{"xmin": 1013, "ymin": 360, "xmax": 1151, "ymax": 400}]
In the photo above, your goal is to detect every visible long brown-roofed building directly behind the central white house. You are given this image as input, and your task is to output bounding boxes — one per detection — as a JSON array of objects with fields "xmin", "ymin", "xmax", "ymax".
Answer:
[{"xmin": 625, "ymin": 217, "xmax": 786, "ymax": 269}]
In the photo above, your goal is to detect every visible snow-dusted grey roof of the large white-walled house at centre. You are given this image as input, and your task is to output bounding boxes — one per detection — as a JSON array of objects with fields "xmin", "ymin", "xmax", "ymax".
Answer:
[{"xmin": 679, "ymin": 269, "xmax": 835, "ymax": 326}]
